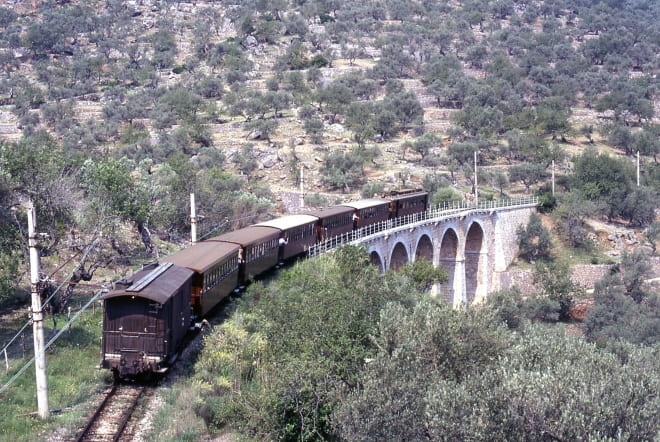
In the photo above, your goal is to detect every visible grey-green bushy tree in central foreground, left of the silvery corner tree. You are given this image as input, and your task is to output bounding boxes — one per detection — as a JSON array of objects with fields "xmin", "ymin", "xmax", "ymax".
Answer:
[{"xmin": 334, "ymin": 301, "xmax": 509, "ymax": 441}]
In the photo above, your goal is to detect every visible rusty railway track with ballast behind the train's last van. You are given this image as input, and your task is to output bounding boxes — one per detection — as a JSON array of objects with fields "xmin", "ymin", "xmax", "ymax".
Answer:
[{"xmin": 75, "ymin": 384, "xmax": 147, "ymax": 442}]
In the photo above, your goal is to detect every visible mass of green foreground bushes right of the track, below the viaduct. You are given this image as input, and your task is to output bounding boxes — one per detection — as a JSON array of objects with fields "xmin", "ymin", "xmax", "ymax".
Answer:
[{"xmin": 154, "ymin": 247, "xmax": 660, "ymax": 440}]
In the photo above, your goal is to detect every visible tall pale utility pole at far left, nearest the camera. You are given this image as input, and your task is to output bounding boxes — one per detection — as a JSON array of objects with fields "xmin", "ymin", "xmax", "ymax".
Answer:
[{"xmin": 27, "ymin": 201, "xmax": 50, "ymax": 419}]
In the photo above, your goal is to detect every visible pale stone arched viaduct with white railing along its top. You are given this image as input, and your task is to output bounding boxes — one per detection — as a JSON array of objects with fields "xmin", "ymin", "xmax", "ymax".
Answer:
[{"xmin": 309, "ymin": 197, "xmax": 538, "ymax": 306}]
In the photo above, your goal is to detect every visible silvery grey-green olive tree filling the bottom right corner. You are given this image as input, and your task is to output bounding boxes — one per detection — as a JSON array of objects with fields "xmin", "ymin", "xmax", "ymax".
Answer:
[{"xmin": 425, "ymin": 326, "xmax": 659, "ymax": 441}]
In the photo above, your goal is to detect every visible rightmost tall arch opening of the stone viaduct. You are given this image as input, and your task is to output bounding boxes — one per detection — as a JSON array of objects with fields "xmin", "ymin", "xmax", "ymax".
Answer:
[{"xmin": 465, "ymin": 221, "xmax": 486, "ymax": 304}]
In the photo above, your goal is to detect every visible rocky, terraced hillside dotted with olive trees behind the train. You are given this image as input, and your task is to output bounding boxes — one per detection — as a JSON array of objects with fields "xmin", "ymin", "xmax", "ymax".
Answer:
[{"xmin": 0, "ymin": 0, "xmax": 660, "ymax": 294}]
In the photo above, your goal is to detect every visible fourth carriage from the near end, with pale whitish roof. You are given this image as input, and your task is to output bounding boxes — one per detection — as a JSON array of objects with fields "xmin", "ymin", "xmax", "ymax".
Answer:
[{"xmin": 256, "ymin": 215, "xmax": 318, "ymax": 260}]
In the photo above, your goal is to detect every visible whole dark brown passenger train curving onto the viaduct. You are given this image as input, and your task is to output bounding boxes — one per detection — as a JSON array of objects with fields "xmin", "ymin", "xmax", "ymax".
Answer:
[{"xmin": 99, "ymin": 189, "xmax": 428, "ymax": 378}]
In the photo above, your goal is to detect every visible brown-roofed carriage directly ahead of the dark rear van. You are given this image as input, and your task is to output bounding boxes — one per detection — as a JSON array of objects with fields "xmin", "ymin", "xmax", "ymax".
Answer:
[{"xmin": 163, "ymin": 241, "xmax": 240, "ymax": 316}]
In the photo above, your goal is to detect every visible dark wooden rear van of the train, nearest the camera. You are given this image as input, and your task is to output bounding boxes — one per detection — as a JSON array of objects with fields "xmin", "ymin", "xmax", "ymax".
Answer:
[{"xmin": 101, "ymin": 263, "xmax": 193, "ymax": 377}]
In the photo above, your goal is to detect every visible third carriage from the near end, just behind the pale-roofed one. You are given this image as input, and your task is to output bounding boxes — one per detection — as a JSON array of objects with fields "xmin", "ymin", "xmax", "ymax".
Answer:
[{"xmin": 210, "ymin": 226, "xmax": 280, "ymax": 284}]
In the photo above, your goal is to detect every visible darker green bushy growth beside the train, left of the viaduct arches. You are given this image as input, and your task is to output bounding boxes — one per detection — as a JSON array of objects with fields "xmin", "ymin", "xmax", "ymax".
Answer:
[{"xmin": 196, "ymin": 247, "xmax": 419, "ymax": 440}]
